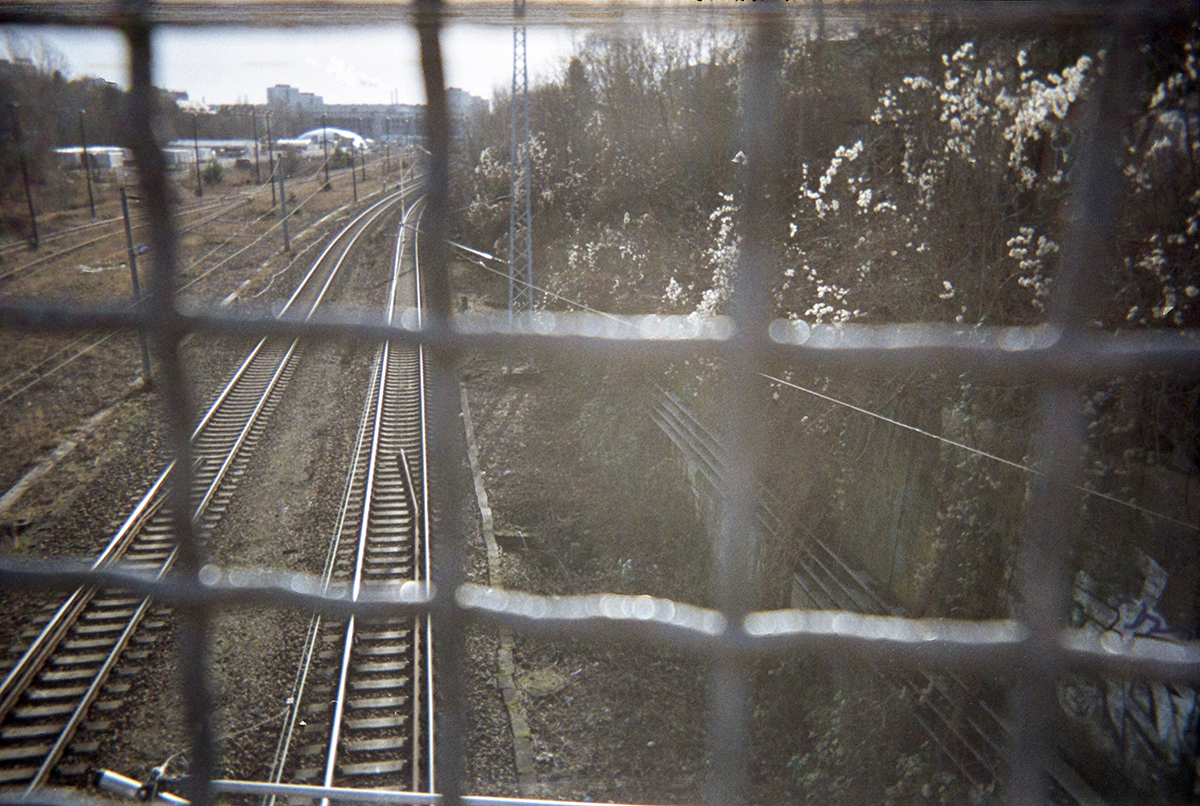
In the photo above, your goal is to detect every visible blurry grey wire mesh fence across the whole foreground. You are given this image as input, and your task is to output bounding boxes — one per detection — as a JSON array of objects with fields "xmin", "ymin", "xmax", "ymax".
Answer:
[{"xmin": 0, "ymin": 1, "xmax": 1200, "ymax": 805}]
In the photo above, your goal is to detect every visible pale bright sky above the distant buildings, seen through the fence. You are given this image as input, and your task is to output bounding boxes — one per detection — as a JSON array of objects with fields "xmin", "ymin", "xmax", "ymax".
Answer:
[{"xmin": 8, "ymin": 24, "xmax": 581, "ymax": 104}]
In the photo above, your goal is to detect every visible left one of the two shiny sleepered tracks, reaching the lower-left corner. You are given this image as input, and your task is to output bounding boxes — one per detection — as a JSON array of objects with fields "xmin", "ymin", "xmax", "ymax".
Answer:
[{"xmin": 0, "ymin": 185, "xmax": 415, "ymax": 792}]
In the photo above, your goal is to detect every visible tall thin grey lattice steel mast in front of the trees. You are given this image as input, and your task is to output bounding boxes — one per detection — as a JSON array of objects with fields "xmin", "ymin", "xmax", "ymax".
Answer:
[{"xmin": 509, "ymin": 0, "xmax": 533, "ymax": 320}]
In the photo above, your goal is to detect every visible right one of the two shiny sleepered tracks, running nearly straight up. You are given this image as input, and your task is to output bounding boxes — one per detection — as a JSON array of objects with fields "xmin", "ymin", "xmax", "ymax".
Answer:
[{"xmin": 271, "ymin": 205, "xmax": 433, "ymax": 790}]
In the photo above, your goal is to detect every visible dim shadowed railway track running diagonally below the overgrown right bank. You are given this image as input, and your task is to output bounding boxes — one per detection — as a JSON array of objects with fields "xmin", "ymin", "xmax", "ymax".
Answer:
[{"xmin": 650, "ymin": 391, "xmax": 1105, "ymax": 806}]
